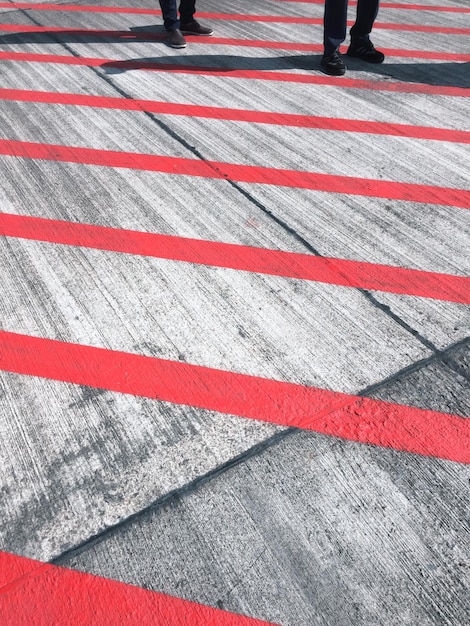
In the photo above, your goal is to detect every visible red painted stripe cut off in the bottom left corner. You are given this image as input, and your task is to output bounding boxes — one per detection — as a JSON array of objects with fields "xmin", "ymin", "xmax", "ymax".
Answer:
[{"xmin": 0, "ymin": 552, "xmax": 273, "ymax": 626}]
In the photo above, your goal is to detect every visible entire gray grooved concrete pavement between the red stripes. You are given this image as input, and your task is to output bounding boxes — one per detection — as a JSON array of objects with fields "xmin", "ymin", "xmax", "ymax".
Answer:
[{"xmin": 0, "ymin": 0, "xmax": 470, "ymax": 626}]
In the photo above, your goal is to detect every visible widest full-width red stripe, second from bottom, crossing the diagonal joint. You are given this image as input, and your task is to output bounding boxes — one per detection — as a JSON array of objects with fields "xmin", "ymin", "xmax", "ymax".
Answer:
[{"xmin": 0, "ymin": 331, "xmax": 470, "ymax": 463}]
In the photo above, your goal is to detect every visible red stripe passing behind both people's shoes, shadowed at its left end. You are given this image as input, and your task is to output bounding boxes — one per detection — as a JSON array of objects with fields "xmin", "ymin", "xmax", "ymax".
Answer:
[{"xmin": 0, "ymin": 24, "xmax": 470, "ymax": 63}]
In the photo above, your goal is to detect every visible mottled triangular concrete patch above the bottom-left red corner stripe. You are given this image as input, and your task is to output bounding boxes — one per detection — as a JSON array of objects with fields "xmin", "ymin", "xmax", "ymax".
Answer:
[{"xmin": 0, "ymin": 372, "xmax": 278, "ymax": 560}]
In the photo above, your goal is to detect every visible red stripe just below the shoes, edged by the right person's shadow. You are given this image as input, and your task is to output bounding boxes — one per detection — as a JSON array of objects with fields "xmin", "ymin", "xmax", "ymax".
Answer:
[{"xmin": 0, "ymin": 52, "xmax": 470, "ymax": 98}]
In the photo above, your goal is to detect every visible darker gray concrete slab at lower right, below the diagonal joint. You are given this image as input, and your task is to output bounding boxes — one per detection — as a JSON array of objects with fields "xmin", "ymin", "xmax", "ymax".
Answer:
[{"xmin": 60, "ymin": 346, "xmax": 470, "ymax": 626}]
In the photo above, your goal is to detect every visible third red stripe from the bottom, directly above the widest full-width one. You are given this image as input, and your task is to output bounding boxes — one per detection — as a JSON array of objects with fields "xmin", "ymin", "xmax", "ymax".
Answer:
[{"xmin": 0, "ymin": 213, "xmax": 470, "ymax": 304}]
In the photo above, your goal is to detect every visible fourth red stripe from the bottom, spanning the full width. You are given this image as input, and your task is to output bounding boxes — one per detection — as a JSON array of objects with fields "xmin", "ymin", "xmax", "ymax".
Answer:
[{"xmin": 0, "ymin": 139, "xmax": 470, "ymax": 209}]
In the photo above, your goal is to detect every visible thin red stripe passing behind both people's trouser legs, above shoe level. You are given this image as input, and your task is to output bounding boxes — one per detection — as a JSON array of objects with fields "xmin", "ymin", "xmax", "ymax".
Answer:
[{"xmin": 0, "ymin": 2, "xmax": 470, "ymax": 35}]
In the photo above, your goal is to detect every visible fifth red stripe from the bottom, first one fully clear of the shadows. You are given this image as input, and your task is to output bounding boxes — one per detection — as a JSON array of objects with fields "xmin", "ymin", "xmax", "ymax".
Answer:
[{"xmin": 0, "ymin": 88, "xmax": 470, "ymax": 143}]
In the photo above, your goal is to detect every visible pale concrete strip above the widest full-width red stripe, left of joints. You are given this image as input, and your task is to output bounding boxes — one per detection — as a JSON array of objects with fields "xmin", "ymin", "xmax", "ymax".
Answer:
[{"xmin": 2, "ymin": 235, "xmax": 429, "ymax": 380}]
